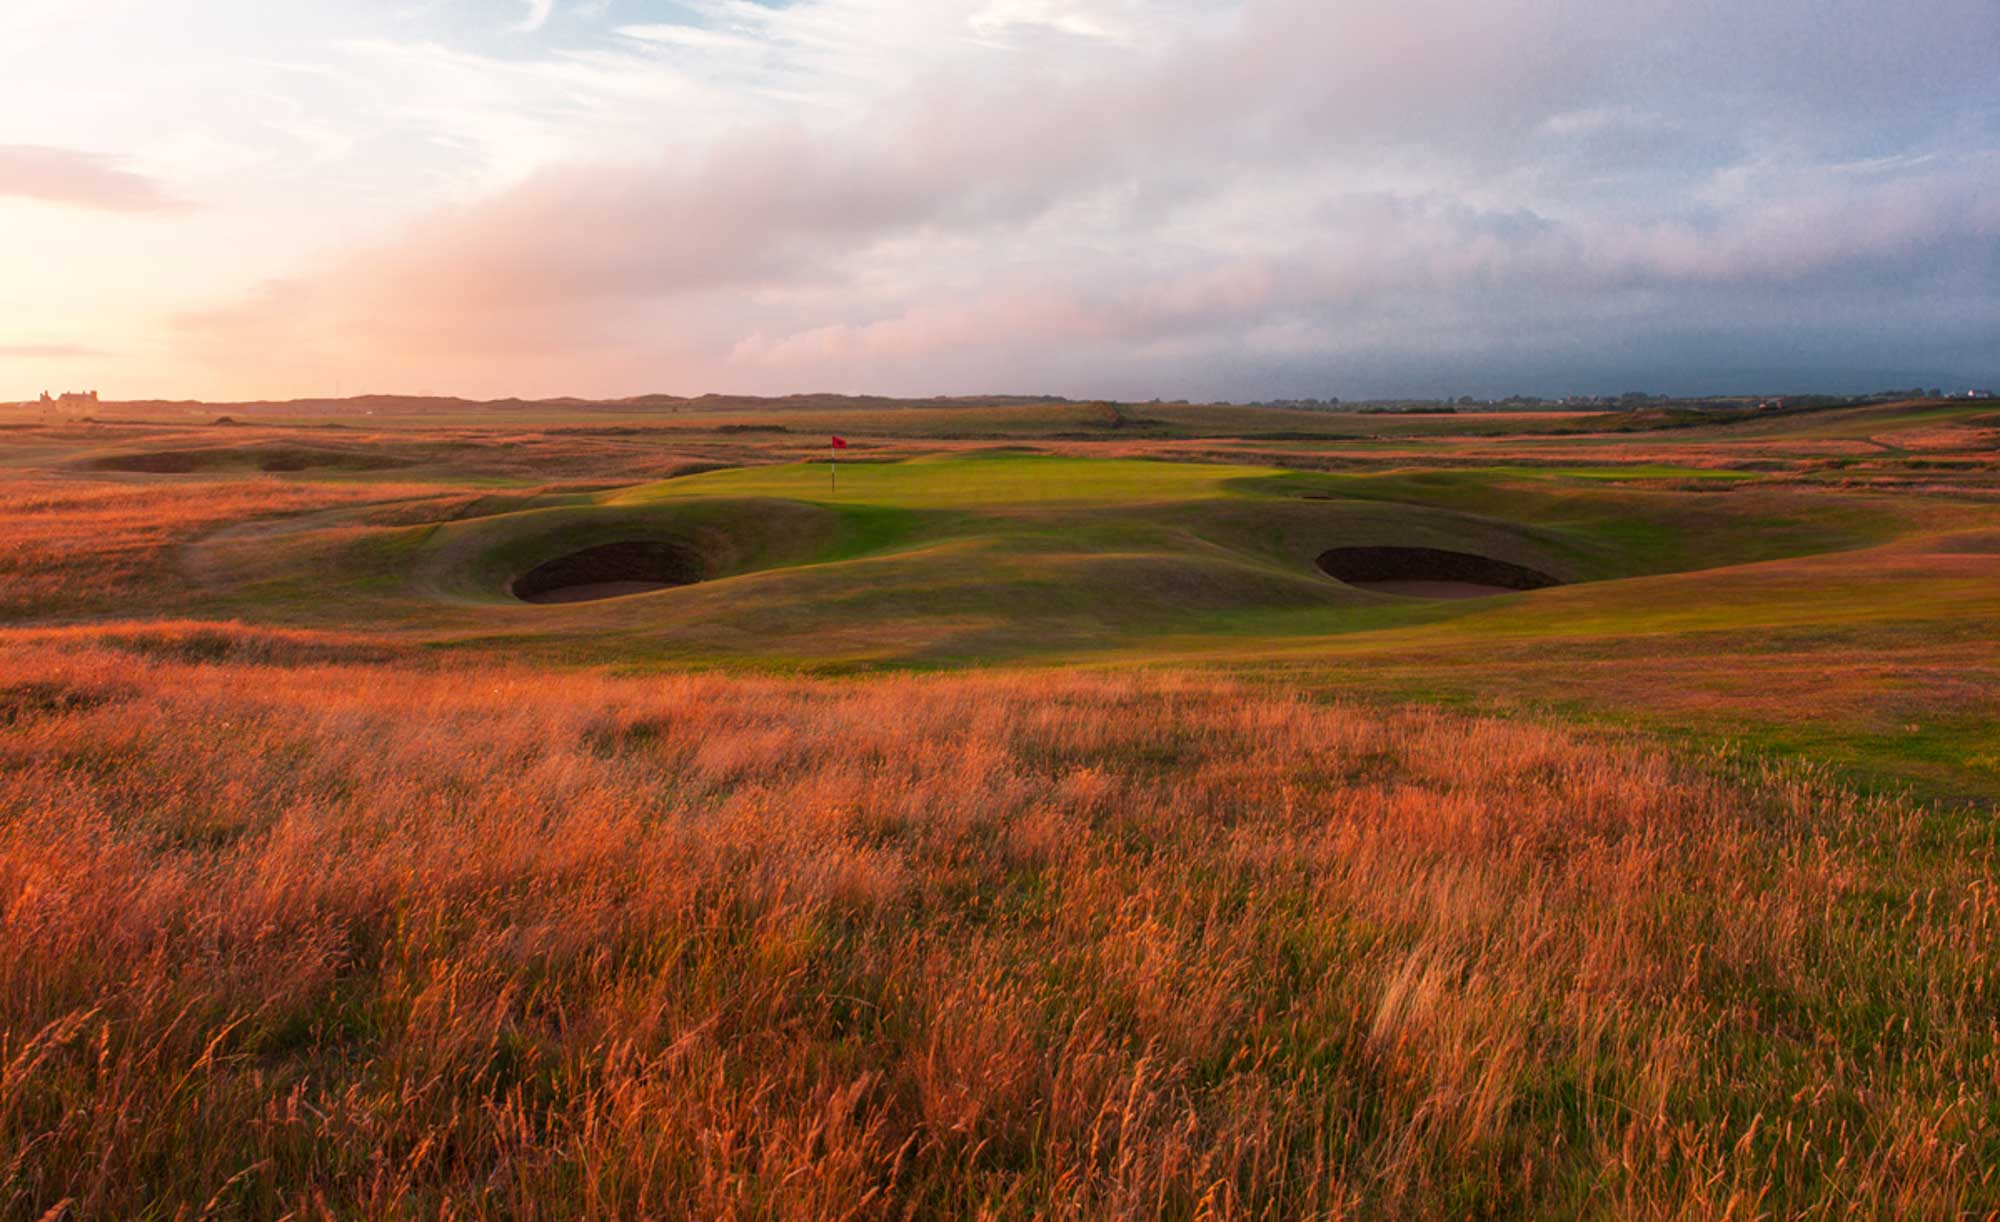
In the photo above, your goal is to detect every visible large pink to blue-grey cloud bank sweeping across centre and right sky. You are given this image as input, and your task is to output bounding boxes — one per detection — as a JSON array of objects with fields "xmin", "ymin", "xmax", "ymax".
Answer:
[{"xmin": 168, "ymin": 0, "xmax": 2000, "ymax": 396}]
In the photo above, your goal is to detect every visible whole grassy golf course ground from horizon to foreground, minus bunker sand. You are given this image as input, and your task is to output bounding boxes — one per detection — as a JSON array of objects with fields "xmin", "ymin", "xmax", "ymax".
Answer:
[{"xmin": 0, "ymin": 404, "xmax": 2000, "ymax": 1218}]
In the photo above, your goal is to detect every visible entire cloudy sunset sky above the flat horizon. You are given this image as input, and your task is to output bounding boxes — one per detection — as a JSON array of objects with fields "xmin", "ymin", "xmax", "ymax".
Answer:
[{"xmin": 0, "ymin": 0, "xmax": 2000, "ymax": 400}]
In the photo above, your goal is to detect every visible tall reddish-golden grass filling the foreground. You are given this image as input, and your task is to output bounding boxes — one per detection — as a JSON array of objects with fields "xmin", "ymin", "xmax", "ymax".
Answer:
[{"xmin": 0, "ymin": 628, "xmax": 2000, "ymax": 1218}]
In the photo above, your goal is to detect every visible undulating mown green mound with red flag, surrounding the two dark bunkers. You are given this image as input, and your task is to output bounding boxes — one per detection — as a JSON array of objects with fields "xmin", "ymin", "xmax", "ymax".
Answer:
[{"xmin": 129, "ymin": 450, "xmax": 1968, "ymax": 668}]
